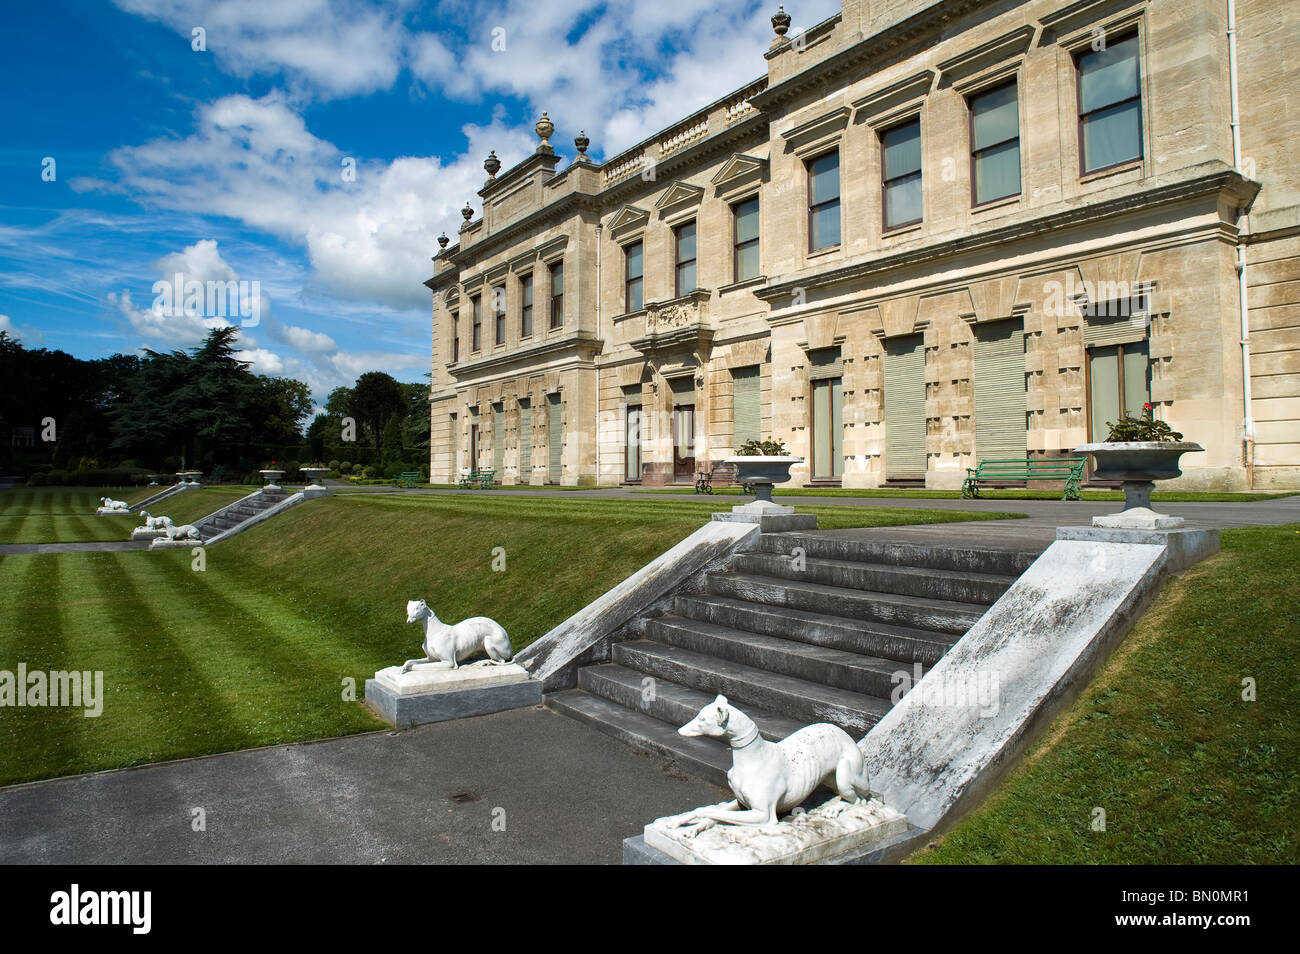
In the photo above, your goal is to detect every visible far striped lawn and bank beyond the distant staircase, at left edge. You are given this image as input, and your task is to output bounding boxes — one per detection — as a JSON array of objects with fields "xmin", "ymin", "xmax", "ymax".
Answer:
[{"xmin": 0, "ymin": 487, "xmax": 252, "ymax": 543}]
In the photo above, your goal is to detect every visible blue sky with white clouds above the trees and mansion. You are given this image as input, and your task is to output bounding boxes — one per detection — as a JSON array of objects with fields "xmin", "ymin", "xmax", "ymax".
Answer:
[{"xmin": 0, "ymin": 0, "xmax": 839, "ymax": 400}]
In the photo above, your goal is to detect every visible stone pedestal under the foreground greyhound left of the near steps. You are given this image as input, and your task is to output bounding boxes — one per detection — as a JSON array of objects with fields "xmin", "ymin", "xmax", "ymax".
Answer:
[{"xmin": 365, "ymin": 663, "xmax": 542, "ymax": 729}]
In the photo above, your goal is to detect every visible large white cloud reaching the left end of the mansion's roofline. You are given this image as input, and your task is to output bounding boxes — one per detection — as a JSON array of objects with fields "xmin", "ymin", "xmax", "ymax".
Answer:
[{"xmin": 72, "ymin": 94, "xmax": 536, "ymax": 308}]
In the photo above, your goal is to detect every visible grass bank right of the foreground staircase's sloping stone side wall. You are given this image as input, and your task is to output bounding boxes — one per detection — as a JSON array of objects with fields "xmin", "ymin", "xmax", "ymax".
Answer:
[{"xmin": 911, "ymin": 524, "xmax": 1300, "ymax": 864}]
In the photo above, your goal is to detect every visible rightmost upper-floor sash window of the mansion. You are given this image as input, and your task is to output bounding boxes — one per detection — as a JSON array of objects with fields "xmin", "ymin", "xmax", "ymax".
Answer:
[{"xmin": 1078, "ymin": 34, "xmax": 1143, "ymax": 175}]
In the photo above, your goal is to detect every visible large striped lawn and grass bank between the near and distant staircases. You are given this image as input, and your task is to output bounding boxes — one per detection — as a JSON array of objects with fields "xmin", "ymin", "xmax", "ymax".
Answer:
[{"xmin": 0, "ymin": 491, "xmax": 1013, "ymax": 784}]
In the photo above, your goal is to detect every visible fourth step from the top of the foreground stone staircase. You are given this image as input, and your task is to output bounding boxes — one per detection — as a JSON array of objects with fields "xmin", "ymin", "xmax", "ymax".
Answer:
[{"xmin": 672, "ymin": 595, "xmax": 957, "ymax": 667}]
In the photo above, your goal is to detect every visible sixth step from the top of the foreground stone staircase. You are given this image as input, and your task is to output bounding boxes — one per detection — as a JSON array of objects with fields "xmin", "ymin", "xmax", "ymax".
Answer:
[{"xmin": 611, "ymin": 639, "xmax": 889, "ymax": 738}]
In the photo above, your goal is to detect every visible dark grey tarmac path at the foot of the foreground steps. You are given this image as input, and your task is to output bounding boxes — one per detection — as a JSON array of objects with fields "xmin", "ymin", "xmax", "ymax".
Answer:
[{"xmin": 0, "ymin": 707, "xmax": 729, "ymax": 864}]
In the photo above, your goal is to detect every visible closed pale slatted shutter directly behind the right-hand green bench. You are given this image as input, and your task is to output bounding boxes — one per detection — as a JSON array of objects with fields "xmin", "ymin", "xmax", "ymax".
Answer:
[{"xmin": 975, "ymin": 321, "xmax": 1028, "ymax": 460}]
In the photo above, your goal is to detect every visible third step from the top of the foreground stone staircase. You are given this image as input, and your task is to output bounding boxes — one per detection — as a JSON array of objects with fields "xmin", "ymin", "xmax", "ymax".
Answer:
[{"xmin": 705, "ymin": 571, "xmax": 988, "ymax": 636}]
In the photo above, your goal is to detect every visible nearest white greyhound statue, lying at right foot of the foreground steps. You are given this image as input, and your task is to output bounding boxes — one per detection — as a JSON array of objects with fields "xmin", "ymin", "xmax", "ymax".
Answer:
[{"xmin": 677, "ymin": 695, "xmax": 871, "ymax": 825}]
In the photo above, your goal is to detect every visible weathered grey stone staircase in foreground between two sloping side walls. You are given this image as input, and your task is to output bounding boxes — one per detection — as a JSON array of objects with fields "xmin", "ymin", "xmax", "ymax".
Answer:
[{"xmin": 547, "ymin": 532, "xmax": 1039, "ymax": 785}]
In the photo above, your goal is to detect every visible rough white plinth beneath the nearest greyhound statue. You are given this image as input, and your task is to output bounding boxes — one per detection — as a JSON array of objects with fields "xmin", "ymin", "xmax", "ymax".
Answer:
[{"xmin": 645, "ymin": 797, "xmax": 907, "ymax": 864}]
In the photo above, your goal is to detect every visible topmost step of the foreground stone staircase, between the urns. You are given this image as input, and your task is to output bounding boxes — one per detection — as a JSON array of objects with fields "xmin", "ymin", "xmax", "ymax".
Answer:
[{"xmin": 758, "ymin": 532, "xmax": 1039, "ymax": 577}]
